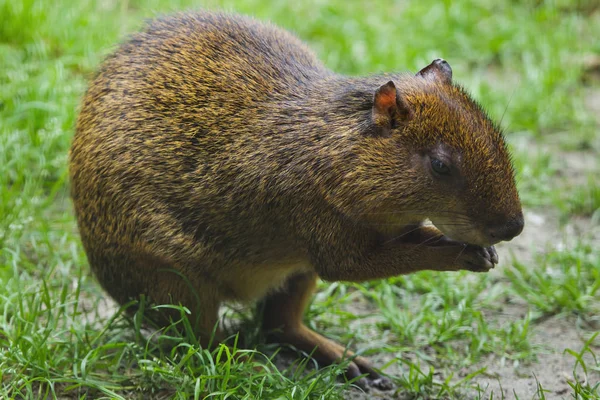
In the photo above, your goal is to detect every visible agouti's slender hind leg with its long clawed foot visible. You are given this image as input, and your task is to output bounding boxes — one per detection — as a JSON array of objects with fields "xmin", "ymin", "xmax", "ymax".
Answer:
[{"xmin": 263, "ymin": 273, "xmax": 392, "ymax": 390}]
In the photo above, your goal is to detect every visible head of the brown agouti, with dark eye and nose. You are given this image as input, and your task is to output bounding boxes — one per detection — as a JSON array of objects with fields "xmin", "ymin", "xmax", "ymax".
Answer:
[{"xmin": 344, "ymin": 59, "xmax": 523, "ymax": 246}]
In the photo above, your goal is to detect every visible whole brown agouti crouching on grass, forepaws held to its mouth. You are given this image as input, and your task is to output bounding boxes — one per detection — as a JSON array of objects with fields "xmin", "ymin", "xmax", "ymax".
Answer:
[{"xmin": 70, "ymin": 12, "xmax": 523, "ymax": 387}]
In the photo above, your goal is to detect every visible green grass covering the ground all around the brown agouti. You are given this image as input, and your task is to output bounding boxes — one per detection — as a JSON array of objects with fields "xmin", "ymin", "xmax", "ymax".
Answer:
[{"xmin": 0, "ymin": 0, "xmax": 600, "ymax": 399}]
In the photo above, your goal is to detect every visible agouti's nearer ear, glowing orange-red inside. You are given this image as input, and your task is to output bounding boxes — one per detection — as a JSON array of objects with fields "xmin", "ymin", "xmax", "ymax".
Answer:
[{"xmin": 371, "ymin": 81, "xmax": 413, "ymax": 134}]
